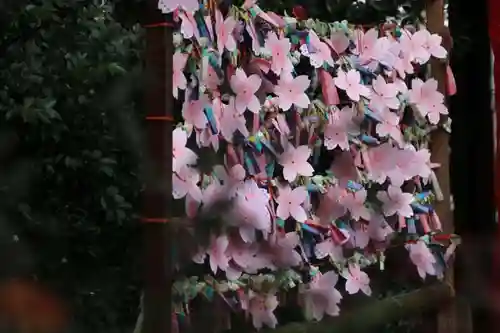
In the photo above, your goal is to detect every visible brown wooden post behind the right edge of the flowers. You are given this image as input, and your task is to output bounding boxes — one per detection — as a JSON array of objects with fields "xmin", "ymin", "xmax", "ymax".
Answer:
[{"xmin": 425, "ymin": 0, "xmax": 463, "ymax": 333}]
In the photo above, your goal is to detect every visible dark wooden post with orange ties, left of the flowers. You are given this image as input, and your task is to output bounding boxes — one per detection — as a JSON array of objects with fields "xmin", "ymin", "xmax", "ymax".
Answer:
[{"xmin": 142, "ymin": 0, "xmax": 173, "ymax": 333}]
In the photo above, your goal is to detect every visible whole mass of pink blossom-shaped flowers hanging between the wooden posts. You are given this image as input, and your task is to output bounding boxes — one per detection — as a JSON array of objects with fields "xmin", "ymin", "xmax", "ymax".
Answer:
[{"xmin": 159, "ymin": 0, "xmax": 458, "ymax": 328}]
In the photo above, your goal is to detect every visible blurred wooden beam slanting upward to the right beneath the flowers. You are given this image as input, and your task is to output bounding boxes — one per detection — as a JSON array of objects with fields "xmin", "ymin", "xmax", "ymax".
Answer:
[{"xmin": 266, "ymin": 282, "xmax": 454, "ymax": 333}]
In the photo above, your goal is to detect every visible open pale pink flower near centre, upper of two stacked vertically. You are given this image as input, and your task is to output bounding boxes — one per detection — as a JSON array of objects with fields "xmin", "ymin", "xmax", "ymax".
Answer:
[{"xmin": 279, "ymin": 145, "xmax": 314, "ymax": 182}]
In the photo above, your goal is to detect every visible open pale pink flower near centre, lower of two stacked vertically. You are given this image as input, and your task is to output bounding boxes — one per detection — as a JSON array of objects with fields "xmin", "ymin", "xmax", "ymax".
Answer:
[{"xmin": 276, "ymin": 186, "xmax": 307, "ymax": 222}]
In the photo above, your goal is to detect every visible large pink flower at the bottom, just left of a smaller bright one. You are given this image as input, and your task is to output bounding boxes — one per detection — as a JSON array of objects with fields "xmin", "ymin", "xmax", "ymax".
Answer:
[{"xmin": 303, "ymin": 271, "xmax": 342, "ymax": 321}]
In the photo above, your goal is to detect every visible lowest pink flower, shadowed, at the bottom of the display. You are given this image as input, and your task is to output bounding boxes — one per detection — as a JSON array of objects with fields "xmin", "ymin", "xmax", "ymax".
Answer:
[{"xmin": 241, "ymin": 292, "xmax": 278, "ymax": 329}]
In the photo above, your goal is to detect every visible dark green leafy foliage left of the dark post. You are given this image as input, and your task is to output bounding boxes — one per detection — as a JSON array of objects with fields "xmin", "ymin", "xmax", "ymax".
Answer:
[{"xmin": 0, "ymin": 0, "xmax": 142, "ymax": 332}]
